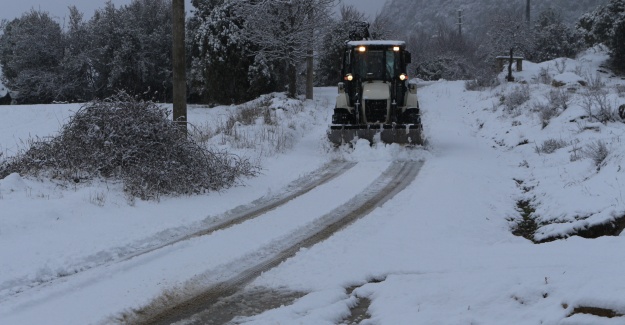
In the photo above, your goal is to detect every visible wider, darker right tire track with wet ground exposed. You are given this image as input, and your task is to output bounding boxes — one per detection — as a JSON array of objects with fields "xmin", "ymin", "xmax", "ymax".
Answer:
[{"xmin": 132, "ymin": 161, "xmax": 423, "ymax": 324}]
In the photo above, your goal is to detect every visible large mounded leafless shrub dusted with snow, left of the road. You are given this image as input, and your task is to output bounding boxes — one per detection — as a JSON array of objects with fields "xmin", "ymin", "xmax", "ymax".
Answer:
[{"xmin": 0, "ymin": 94, "xmax": 256, "ymax": 200}]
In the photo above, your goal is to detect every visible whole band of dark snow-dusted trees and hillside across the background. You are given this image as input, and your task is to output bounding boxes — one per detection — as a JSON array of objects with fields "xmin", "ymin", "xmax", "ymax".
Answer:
[{"xmin": 0, "ymin": 0, "xmax": 625, "ymax": 104}]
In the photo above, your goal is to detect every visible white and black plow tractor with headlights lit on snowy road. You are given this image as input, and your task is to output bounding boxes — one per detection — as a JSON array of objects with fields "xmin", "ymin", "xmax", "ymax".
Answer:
[{"xmin": 328, "ymin": 40, "xmax": 424, "ymax": 145}]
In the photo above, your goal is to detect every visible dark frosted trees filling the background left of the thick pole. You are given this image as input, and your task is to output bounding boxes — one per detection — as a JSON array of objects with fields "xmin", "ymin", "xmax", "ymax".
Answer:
[{"xmin": 0, "ymin": 0, "xmax": 172, "ymax": 103}]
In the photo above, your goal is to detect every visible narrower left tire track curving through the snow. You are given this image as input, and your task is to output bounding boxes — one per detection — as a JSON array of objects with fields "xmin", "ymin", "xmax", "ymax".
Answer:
[{"xmin": 0, "ymin": 161, "xmax": 356, "ymax": 301}]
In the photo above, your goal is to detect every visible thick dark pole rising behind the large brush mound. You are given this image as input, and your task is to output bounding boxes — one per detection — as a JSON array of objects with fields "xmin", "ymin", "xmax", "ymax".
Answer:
[{"xmin": 172, "ymin": 0, "xmax": 187, "ymax": 135}]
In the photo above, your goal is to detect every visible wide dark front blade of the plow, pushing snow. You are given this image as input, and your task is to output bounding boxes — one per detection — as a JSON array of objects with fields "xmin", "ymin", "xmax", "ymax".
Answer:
[{"xmin": 328, "ymin": 124, "xmax": 423, "ymax": 145}]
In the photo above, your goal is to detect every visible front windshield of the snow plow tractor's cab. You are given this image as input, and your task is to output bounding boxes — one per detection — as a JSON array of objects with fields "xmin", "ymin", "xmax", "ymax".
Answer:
[{"xmin": 353, "ymin": 50, "xmax": 397, "ymax": 80}]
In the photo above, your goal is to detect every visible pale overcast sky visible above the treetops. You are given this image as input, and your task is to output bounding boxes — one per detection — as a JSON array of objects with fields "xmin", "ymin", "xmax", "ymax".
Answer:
[{"xmin": 0, "ymin": 0, "xmax": 386, "ymax": 20}]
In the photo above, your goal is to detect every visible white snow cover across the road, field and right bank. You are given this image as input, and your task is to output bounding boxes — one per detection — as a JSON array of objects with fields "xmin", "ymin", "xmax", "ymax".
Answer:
[{"xmin": 0, "ymin": 51, "xmax": 625, "ymax": 325}]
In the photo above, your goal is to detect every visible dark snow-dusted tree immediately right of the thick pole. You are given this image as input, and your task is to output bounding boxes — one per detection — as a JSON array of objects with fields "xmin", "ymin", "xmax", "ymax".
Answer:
[{"xmin": 189, "ymin": 0, "xmax": 275, "ymax": 104}]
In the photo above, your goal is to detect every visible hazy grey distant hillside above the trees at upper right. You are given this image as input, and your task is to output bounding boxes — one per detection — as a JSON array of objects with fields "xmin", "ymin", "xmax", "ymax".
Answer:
[{"xmin": 381, "ymin": 0, "xmax": 608, "ymax": 34}]
